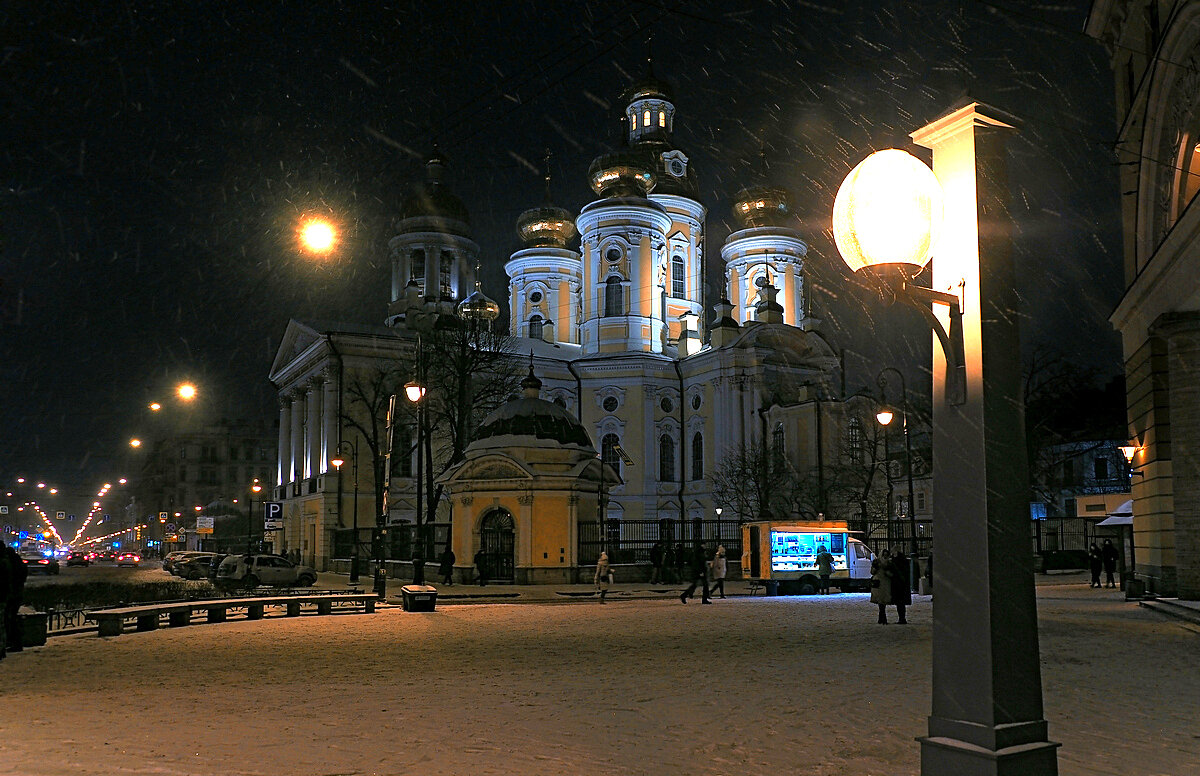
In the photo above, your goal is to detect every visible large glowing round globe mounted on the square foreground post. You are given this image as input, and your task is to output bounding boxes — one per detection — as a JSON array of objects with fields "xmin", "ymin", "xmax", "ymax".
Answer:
[{"xmin": 833, "ymin": 149, "xmax": 942, "ymax": 277}]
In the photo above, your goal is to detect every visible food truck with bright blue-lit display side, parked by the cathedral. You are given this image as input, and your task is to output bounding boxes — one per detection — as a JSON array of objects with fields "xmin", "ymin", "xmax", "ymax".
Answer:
[{"xmin": 742, "ymin": 521, "xmax": 875, "ymax": 595}]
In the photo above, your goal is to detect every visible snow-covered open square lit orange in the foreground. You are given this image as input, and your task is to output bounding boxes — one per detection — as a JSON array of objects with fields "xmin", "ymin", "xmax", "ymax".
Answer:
[{"xmin": 0, "ymin": 583, "xmax": 1200, "ymax": 776}]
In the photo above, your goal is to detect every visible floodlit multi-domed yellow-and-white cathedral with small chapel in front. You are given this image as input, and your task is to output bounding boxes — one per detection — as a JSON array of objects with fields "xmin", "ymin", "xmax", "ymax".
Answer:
[{"xmin": 270, "ymin": 68, "xmax": 848, "ymax": 583}]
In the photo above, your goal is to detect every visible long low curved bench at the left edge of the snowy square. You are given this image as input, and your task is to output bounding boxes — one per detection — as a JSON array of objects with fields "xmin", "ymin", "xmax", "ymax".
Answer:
[{"xmin": 84, "ymin": 592, "xmax": 379, "ymax": 637}]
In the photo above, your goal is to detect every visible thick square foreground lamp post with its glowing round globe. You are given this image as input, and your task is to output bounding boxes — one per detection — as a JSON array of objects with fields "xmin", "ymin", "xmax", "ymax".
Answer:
[{"xmin": 834, "ymin": 103, "xmax": 1058, "ymax": 776}]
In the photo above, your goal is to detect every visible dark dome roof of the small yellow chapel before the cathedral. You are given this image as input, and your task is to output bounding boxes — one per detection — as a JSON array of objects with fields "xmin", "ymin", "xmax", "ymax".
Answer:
[{"xmin": 468, "ymin": 367, "xmax": 595, "ymax": 455}]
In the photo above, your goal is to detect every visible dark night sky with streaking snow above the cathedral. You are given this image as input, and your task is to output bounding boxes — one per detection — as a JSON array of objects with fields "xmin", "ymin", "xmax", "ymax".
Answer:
[{"xmin": 0, "ymin": 0, "xmax": 1121, "ymax": 511}]
